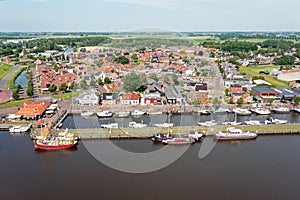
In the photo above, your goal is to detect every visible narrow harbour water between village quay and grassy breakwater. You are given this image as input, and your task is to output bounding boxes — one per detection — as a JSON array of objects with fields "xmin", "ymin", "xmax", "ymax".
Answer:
[{"xmin": 62, "ymin": 112, "xmax": 300, "ymax": 128}]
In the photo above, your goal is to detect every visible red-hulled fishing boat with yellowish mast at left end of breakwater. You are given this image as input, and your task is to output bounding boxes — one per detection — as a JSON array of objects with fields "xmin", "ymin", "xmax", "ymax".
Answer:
[{"xmin": 34, "ymin": 123, "xmax": 78, "ymax": 150}]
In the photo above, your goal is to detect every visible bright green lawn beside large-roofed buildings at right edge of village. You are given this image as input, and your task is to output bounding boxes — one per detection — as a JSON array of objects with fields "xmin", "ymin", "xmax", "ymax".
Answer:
[{"xmin": 239, "ymin": 65, "xmax": 289, "ymax": 88}]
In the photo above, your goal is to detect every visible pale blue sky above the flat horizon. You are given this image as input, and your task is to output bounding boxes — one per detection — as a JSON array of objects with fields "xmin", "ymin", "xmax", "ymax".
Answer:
[{"xmin": 0, "ymin": 0, "xmax": 300, "ymax": 32}]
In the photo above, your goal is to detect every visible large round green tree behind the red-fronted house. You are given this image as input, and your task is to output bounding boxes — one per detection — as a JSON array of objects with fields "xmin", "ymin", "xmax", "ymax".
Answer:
[{"xmin": 124, "ymin": 72, "xmax": 144, "ymax": 92}]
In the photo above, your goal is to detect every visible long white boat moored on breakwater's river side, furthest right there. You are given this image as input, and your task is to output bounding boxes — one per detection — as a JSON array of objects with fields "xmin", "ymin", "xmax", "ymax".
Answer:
[{"xmin": 215, "ymin": 127, "xmax": 257, "ymax": 140}]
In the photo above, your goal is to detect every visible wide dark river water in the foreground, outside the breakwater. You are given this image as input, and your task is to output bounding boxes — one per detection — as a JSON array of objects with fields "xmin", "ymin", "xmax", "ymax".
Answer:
[{"xmin": 0, "ymin": 132, "xmax": 300, "ymax": 200}]
